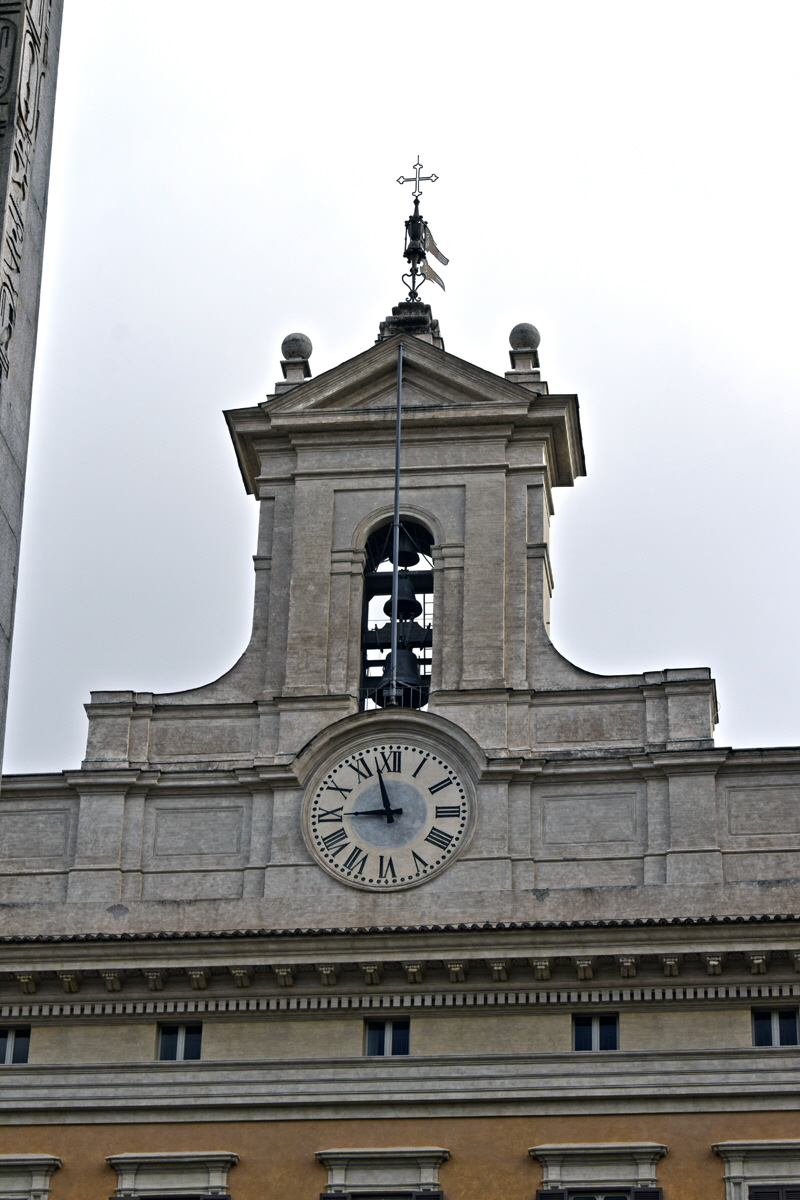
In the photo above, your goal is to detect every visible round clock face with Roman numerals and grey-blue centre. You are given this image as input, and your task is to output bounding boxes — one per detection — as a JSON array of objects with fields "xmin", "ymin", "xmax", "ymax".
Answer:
[{"xmin": 303, "ymin": 740, "xmax": 473, "ymax": 892}]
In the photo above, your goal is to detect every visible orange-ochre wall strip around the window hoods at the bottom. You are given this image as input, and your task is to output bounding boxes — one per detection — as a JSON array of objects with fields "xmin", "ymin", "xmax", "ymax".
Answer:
[{"xmin": 0, "ymin": 1112, "xmax": 800, "ymax": 1200}]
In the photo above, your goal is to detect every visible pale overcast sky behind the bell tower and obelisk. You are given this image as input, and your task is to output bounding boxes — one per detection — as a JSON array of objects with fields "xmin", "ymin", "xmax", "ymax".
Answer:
[{"xmin": 6, "ymin": 0, "xmax": 800, "ymax": 772}]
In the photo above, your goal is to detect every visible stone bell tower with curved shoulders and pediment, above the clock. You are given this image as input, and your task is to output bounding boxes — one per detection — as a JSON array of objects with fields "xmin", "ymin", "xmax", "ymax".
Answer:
[{"xmin": 88, "ymin": 301, "xmax": 715, "ymax": 762}]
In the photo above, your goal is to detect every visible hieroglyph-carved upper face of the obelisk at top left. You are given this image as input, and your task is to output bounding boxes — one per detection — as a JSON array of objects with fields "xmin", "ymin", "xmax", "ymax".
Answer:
[{"xmin": 0, "ymin": 0, "xmax": 52, "ymax": 369}]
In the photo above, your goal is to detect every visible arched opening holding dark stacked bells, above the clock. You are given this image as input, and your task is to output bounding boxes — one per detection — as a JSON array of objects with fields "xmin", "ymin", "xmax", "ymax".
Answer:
[{"xmin": 360, "ymin": 517, "xmax": 433, "ymax": 710}]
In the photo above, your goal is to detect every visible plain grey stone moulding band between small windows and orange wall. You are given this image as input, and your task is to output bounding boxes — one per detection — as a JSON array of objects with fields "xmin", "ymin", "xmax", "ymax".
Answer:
[{"xmin": 0, "ymin": 1046, "xmax": 800, "ymax": 1124}]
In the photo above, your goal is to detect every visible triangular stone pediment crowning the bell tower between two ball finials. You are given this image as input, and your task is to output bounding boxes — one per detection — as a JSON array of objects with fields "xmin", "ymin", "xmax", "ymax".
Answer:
[{"xmin": 261, "ymin": 334, "xmax": 531, "ymax": 416}]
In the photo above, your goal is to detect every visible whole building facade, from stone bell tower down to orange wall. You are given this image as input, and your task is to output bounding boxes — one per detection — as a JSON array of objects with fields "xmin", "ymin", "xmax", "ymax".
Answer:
[{"xmin": 0, "ymin": 314, "xmax": 800, "ymax": 1200}]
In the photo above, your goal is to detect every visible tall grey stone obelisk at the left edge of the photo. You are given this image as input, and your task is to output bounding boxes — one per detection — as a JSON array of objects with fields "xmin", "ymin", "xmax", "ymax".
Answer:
[{"xmin": 0, "ymin": 0, "xmax": 64, "ymax": 761}]
